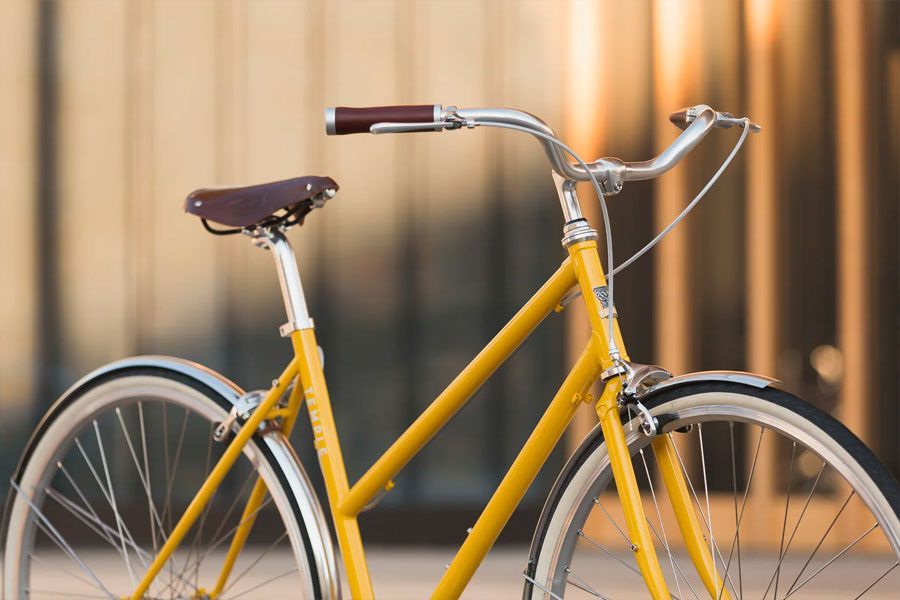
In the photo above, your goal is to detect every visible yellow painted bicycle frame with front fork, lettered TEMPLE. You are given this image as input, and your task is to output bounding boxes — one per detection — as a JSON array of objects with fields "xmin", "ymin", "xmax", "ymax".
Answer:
[{"xmin": 131, "ymin": 240, "xmax": 729, "ymax": 600}]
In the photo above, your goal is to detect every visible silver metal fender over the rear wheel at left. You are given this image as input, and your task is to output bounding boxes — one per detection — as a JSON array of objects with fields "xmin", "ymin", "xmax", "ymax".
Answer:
[{"xmin": 14, "ymin": 356, "xmax": 341, "ymax": 598}]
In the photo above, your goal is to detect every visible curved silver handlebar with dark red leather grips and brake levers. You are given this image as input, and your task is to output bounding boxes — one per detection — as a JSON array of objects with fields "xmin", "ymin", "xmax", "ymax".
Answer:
[{"xmin": 325, "ymin": 104, "xmax": 760, "ymax": 194}]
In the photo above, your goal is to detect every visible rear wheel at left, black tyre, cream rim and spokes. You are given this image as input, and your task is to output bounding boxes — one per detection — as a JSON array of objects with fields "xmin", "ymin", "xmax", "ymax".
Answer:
[{"xmin": 3, "ymin": 370, "xmax": 323, "ymax": 599}]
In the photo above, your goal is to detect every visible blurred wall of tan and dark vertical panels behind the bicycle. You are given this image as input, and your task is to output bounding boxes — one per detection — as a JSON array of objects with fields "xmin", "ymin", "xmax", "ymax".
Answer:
[{"xmin": 0, "ymin": 0, "xmax": 900, "ymax": 546}]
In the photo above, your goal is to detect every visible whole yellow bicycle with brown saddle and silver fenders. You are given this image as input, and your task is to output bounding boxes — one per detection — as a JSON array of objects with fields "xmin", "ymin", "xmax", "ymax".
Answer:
[{"xmin": 0, "ymin": 105, "xmax": 900, "ymax": 599}]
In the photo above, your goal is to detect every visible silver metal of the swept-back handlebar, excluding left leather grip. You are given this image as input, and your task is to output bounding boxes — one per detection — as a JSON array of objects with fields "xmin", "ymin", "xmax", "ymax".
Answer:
[{"xmin": 356, "ymin": 104, "xmax": 760, "ymax": 194}]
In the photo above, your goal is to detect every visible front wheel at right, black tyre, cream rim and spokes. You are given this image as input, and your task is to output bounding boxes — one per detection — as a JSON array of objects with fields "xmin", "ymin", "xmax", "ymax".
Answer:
[{"xmin": 524, "ymin": 382, "xmax": 900, "ymax": 600}]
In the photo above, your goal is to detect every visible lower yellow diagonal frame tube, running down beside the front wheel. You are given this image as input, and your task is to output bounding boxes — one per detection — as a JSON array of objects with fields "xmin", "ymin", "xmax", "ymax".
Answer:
[{"xmin": 432, "ymin": 341, "xmax": 599, "ymax": 599}]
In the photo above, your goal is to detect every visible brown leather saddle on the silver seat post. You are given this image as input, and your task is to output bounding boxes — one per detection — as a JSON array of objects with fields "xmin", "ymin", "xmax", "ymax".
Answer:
[{"xmin": 184, "ymin": 175, "xmax": 338, "ymax": 233}]
